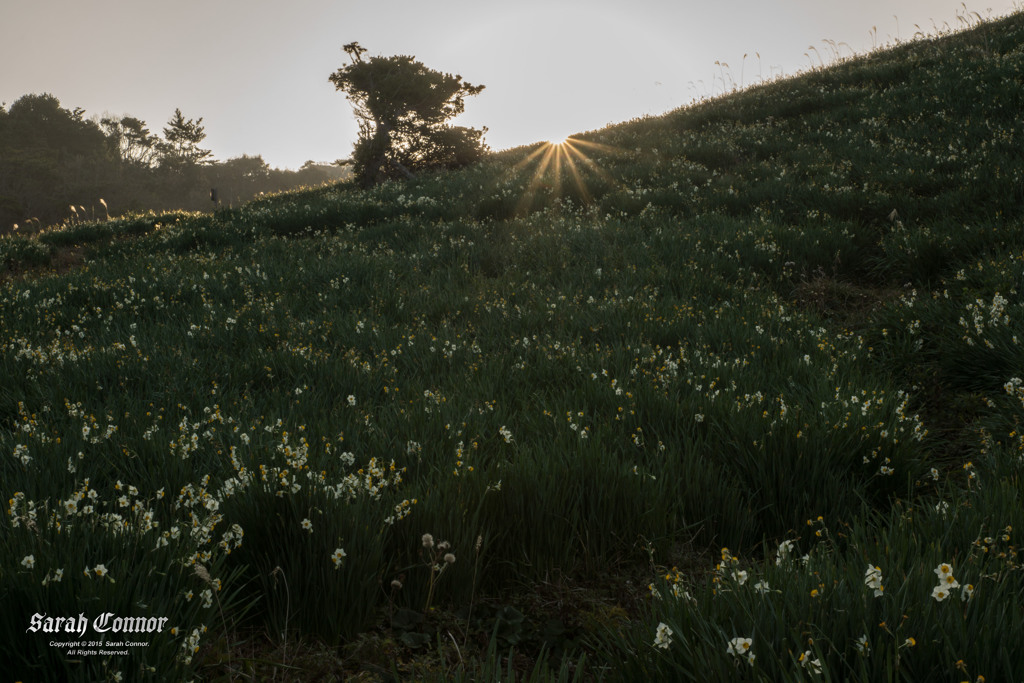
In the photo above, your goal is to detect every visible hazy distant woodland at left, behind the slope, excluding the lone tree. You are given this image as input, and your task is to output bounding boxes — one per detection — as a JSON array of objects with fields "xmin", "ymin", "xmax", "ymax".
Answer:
[{"xmin": 0, "ymin": 94, "xmax": 349, "ymax": 233}]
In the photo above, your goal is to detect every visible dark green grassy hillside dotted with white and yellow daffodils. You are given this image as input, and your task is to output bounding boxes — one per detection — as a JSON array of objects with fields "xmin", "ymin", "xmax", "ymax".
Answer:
[{"xmin": 0, "ymin": 13, "xmax": 1024, "ymax": 681}]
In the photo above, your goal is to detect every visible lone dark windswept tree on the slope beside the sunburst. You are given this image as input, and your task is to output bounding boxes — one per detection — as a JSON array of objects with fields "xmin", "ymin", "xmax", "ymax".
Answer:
[{"xmin": 329, "ymin": 43, "xmax": 486, "ymax": 187}]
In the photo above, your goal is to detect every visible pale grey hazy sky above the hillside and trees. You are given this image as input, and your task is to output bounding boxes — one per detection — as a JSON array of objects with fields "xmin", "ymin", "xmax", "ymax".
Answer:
[{"xmin": 0, "ymin": 0, "xmax": 1024, "ymax": 169}]
